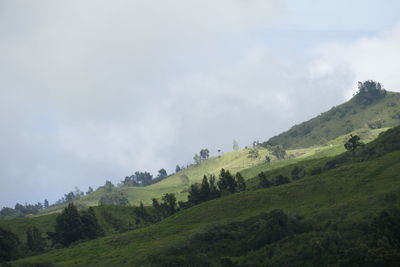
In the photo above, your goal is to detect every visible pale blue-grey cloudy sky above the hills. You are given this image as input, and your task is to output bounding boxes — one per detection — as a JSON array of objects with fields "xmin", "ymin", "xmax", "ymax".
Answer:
[{"xmin": 0, "ymin": 0, "xmax": 400, "ymax": 207}]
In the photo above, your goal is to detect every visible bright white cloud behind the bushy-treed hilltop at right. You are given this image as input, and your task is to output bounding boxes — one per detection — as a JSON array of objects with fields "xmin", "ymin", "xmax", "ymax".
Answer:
[{"xmin": 311, "ymin": 25, "xmax": 400, "ymax": 97}]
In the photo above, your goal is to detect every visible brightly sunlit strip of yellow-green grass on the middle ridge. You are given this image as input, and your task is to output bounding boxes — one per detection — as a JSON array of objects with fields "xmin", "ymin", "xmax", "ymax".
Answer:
[{"xmin": 42, "ymin": 128, "xmax": 388, "ymax": 217}]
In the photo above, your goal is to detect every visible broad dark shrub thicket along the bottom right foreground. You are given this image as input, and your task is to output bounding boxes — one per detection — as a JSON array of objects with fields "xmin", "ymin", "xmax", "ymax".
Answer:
[{"xmin": 146, "ymin": 209, "xmax": 400, "ymax": 266}]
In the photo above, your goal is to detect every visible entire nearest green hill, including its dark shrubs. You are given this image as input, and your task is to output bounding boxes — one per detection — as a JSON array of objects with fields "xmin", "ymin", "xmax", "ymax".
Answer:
[{"xmin": 13, "ymin": 127, "xmax": 400, "ymax": 266}]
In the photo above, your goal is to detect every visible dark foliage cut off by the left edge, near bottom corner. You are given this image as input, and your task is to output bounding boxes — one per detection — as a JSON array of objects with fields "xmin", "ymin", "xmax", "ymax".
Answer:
[{"xmin": 0, "ymin": 228, "xmax": 20, "ymax": 262}]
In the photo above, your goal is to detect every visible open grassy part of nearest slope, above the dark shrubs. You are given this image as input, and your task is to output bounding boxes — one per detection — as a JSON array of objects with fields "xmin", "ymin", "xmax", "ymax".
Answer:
[{"xmin": 14, "ymin": 128, "xmax": 400, "ymax": 266}]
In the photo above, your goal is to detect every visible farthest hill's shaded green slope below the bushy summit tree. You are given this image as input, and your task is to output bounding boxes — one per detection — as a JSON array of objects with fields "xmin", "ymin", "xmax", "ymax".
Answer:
[{"xmin": 266, "ymin": 92, "xmax": 400, "ymax": 149}]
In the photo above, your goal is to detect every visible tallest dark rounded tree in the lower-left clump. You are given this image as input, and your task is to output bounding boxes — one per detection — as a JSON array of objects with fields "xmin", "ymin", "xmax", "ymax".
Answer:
[{"xmin": 51, "ymin": 203, "xmax": 84, "ymax": 246}]
